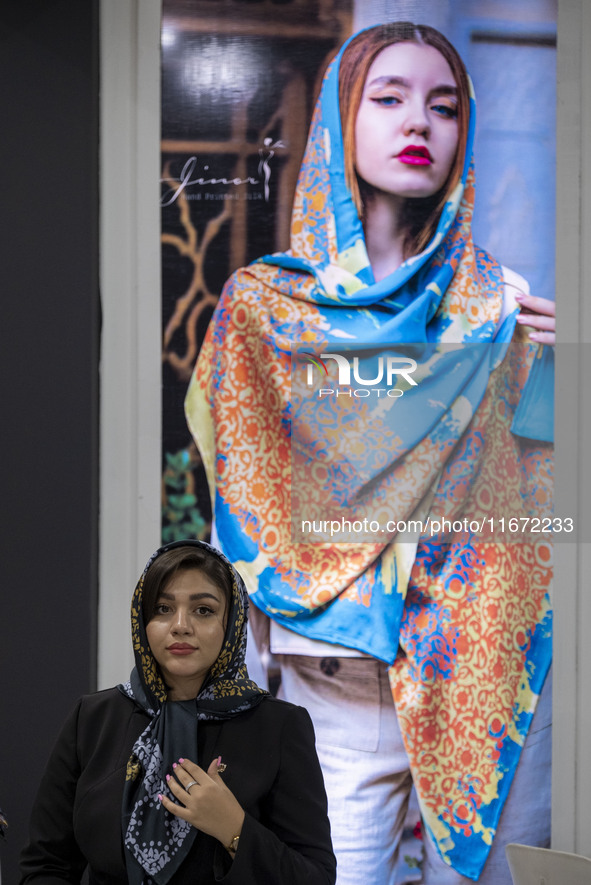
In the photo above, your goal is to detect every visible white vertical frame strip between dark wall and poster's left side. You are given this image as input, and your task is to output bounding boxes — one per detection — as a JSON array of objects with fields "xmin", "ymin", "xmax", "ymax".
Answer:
[{"xmin": 97, "ymin": 0, "xmax": 161, "ymax": 688}]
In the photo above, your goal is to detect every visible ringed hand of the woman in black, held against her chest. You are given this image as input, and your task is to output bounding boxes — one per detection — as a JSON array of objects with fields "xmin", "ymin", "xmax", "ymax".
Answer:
[{"xmin": 160, "ymin": 757, "xmax": 244, "ymax": 848}]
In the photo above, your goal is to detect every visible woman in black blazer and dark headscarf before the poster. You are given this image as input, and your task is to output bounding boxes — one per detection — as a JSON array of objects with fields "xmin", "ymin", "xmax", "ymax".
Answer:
[{"xmin": 21, "ymin": 541, "xmax": 335, "ymax": 885}]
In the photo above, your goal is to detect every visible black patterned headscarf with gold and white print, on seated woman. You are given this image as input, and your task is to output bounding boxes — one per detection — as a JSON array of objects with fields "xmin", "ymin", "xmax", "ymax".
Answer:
[{"xmin": 119, "ymin": 541, "xmax": 268, "ymax": 885}]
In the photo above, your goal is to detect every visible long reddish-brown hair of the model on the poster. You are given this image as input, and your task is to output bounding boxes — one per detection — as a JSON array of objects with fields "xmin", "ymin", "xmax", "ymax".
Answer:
[{"xmin": 339, "ymin": 22, "xmax": 470, "ymax": 258}]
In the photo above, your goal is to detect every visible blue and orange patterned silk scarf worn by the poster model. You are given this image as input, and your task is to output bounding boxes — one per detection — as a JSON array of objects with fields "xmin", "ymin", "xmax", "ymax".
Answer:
[{"xmin": 186, "ymin": 29, "xmax": 553, "ymax": 878}]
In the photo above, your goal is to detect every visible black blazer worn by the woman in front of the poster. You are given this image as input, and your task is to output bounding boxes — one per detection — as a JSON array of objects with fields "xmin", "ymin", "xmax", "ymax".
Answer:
[{"xmin": 21, "ymin": 688, "xmax": 336, "ymax": 885}]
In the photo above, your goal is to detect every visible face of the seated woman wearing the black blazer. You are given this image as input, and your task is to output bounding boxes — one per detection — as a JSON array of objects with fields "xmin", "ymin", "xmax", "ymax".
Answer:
[{"xmin": 146, "ymin": 569, "xmax": 226, "ymax": 701}]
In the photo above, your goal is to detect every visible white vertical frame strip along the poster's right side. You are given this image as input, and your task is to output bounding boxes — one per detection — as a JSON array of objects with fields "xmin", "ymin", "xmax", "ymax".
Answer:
[{"xmin": 552, "ymin": 0, "xmax": 591, "ymax": 857}]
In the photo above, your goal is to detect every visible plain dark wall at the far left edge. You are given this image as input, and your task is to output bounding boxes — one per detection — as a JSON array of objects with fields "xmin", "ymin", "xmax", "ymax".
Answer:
[{"xmin": 0, "ymin": 0, "xmax": 99, "ymax": 885}]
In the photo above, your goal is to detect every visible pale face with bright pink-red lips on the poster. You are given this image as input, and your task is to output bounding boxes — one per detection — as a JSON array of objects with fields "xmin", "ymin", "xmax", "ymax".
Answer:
[{"xmin": 355, "ymin": 42, "xmax": 458, "ymax": 198}]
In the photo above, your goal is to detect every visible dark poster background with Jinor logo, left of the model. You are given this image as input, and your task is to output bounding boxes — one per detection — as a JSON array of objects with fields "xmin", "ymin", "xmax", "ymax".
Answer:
[{"xmin": 162, "ymin": 2, "xmax": 352, "ymax": 540}]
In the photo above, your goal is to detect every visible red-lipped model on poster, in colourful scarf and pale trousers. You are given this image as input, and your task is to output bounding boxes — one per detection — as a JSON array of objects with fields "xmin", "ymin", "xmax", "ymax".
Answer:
[{"xmin": 187, "ymin": 23, "xmax": 554, "ymax": 885}]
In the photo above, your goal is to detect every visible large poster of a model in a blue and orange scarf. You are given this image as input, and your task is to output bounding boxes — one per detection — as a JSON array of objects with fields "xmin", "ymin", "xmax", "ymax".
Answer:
[{"xmin": 162, "ymin": 0, "xmax": 555, "ymax": 883}]
